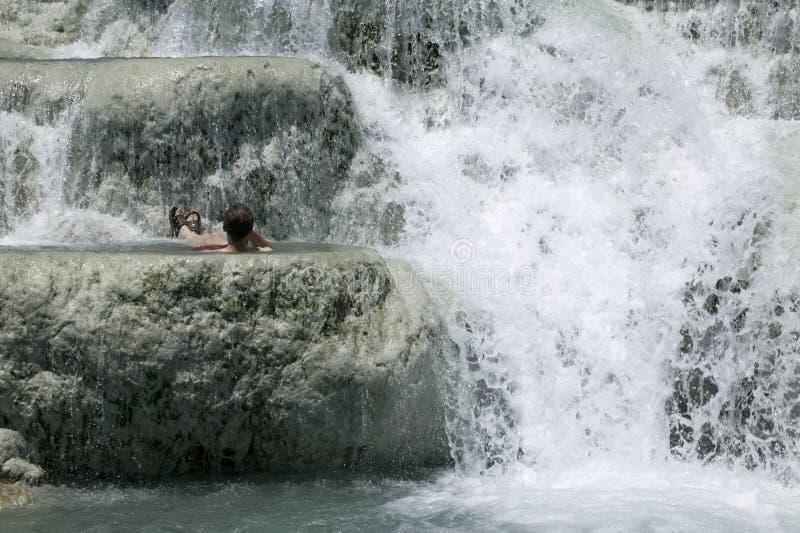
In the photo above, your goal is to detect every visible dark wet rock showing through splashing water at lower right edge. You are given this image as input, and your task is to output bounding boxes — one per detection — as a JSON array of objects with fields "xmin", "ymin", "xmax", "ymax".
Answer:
[{"xmin": 666, "ymin": 218, "xmax": 800, "ymax": 479}]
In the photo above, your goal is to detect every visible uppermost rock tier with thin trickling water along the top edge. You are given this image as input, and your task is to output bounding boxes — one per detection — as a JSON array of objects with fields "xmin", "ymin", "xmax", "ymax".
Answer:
[{"xmin": 0, "ymin": 0, "xmax": 542, "ymax": 86}]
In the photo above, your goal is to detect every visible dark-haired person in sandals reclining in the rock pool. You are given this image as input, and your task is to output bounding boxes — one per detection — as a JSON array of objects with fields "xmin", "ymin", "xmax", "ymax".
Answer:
[{"xmin": 169, "ymin": 203, "xmax": 272, "ymax": 252}]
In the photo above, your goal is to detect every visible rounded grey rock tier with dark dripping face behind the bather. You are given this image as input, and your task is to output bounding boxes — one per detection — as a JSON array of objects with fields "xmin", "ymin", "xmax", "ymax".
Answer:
[{"xmin": 0, "ymin": 58, "xmax": 359, "ymax": 239}]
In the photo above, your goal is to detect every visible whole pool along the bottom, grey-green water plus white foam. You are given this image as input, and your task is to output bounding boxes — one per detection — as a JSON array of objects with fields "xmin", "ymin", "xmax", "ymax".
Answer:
[{"xmin": 6, "ymin": 463, "xmax": 800, "ymax": 532}]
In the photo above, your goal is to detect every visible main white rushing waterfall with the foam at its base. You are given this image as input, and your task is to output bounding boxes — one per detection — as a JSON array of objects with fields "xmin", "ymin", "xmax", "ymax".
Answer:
[{"xmin": 340, "ymin": 2, "xmax": 800, "ymax": 520}]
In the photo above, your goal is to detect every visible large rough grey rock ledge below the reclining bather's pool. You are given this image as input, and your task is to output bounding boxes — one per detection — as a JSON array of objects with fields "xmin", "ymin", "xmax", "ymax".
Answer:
[{"xmin": 0, "ymin": 248, "xmax": 457, "ymax": 480}]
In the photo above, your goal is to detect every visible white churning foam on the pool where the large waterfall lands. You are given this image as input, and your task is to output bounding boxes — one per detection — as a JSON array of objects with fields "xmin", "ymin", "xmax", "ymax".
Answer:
[{"xmin": 385, "ymin": 459, "xmax": 800, "ymax": 532}]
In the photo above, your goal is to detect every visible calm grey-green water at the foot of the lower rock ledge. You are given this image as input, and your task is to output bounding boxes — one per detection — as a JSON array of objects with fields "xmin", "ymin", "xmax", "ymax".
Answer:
[{"xmin": 0, "ymin": 472, "xmax": 438, "ymax": 532}]
